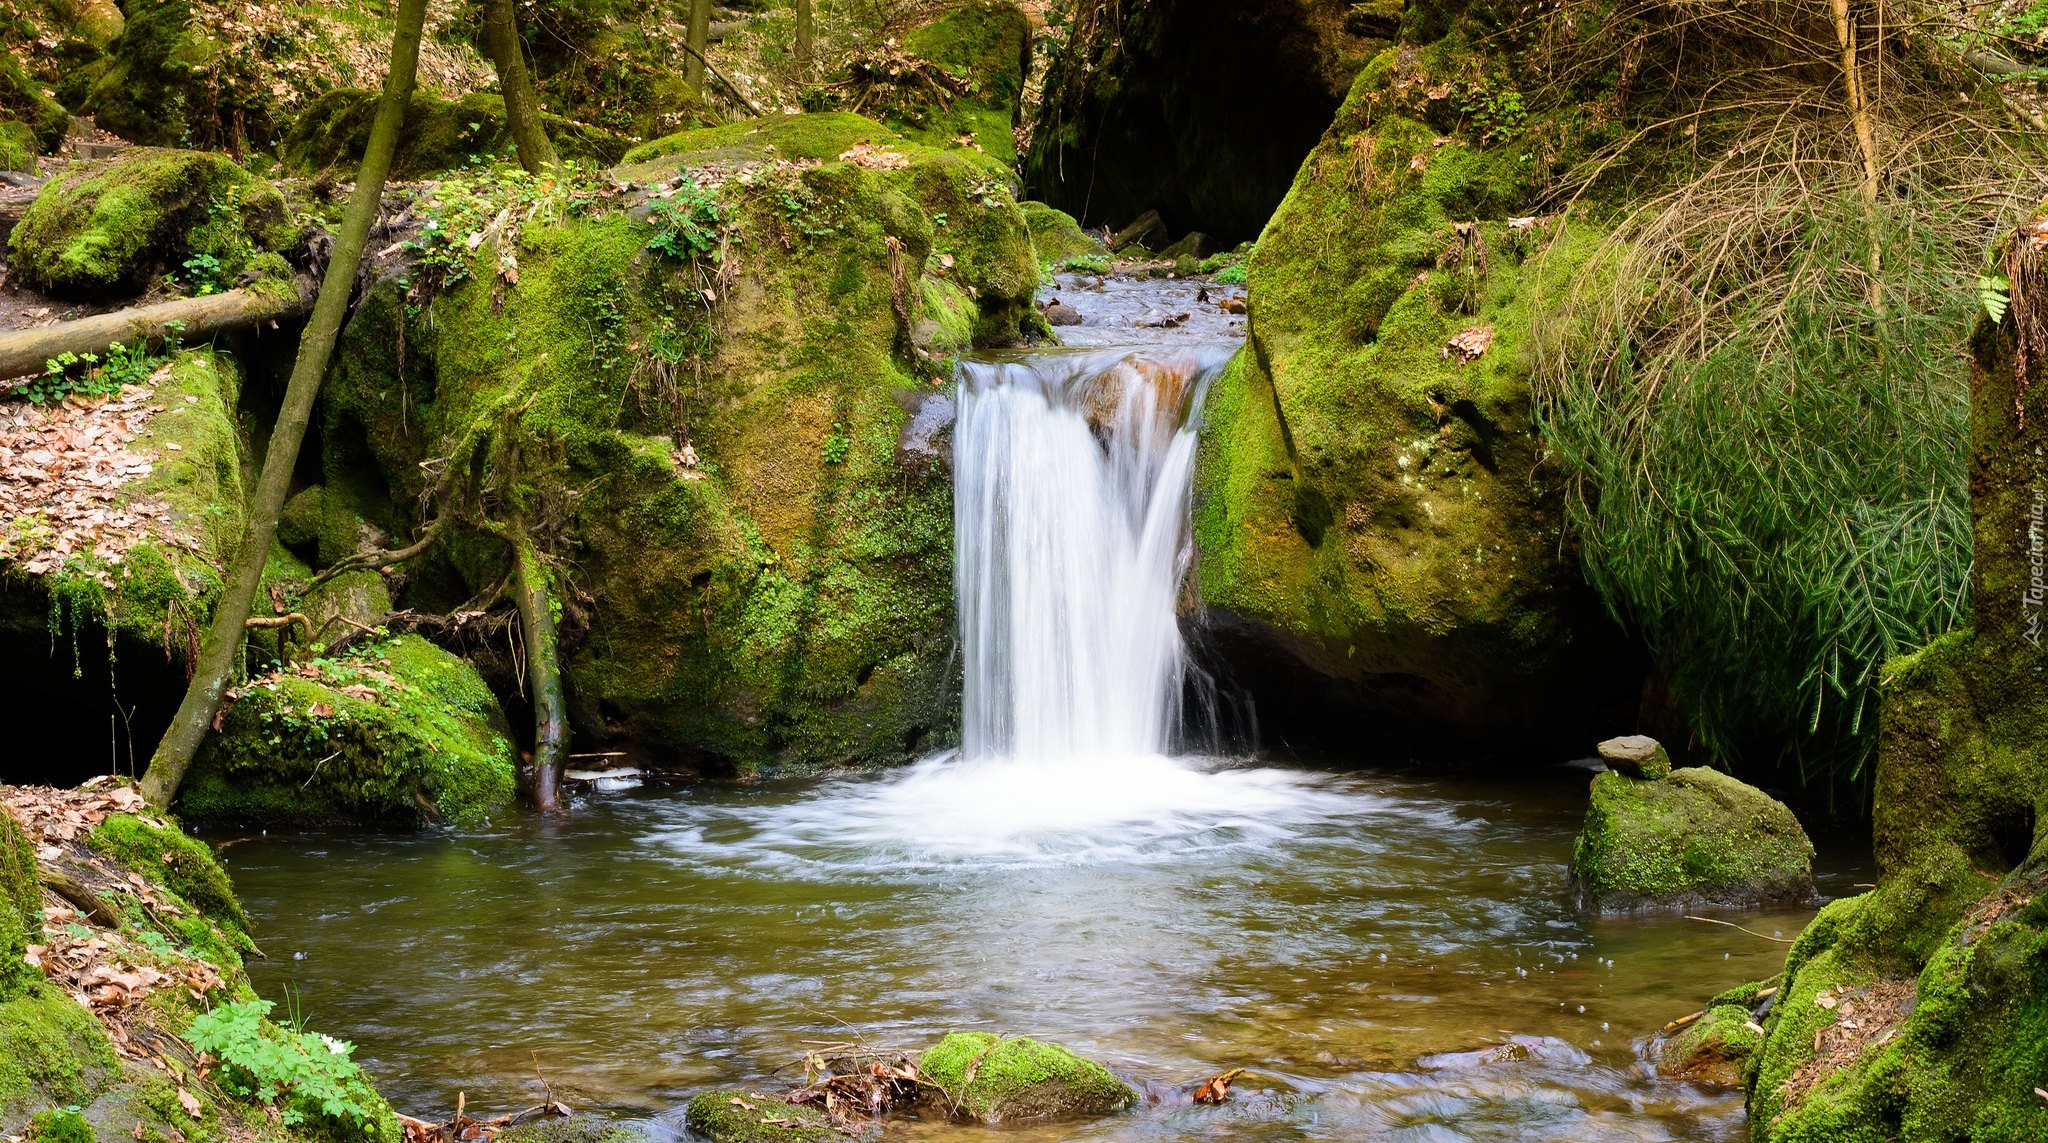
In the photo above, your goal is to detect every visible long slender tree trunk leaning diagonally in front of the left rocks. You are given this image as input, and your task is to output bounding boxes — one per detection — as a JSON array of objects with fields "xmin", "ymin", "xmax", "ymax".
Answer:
[{"xmin": 141, "ymin": 0, "xmax": 426, "ymax": 809}]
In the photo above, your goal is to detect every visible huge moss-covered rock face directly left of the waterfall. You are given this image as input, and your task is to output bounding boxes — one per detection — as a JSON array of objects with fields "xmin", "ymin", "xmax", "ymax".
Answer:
[{"xmin": 324, "ymin": 113, "xmax": 1038, "ymax": 772}]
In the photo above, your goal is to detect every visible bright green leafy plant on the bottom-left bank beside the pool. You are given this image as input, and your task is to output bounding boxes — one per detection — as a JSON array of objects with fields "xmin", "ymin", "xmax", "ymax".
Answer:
[{"xmin": 184, "ymin": 1000, "xmax": 375, "ymax": 1127}]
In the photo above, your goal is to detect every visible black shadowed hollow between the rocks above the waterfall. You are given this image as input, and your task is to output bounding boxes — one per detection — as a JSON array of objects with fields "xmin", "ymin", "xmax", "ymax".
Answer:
[{"xmin": 1024, "ymin": 0, "xmax": 1399, "ymax": 250}]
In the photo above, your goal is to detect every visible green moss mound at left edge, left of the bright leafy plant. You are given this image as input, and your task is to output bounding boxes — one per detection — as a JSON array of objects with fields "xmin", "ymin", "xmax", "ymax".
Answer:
[{"xmin": 0, "ymin": 983, "xmax": 121, "ymax": 1118}]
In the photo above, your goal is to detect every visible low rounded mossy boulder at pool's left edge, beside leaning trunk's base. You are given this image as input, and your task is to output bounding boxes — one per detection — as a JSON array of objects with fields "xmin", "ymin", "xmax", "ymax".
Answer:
[{"xmin": 178, "ymin": 635, "xmax": 518, "ymax": 826}]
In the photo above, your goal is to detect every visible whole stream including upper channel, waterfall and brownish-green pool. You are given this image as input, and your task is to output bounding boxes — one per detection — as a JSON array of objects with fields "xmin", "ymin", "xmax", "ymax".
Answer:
[{"xmin": 211, "ymin": 279, "xmax": 1864, "ymax": 1143}]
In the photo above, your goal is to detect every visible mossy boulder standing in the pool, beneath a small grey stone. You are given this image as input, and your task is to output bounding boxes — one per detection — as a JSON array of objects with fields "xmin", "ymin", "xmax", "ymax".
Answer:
[{"xmin": 1571, "ymin": 766, "xmax": 1812, "ymax": 912}]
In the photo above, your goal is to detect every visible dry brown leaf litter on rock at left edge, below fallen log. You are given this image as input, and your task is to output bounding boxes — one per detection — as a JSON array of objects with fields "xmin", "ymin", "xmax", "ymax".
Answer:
[{"xmin": 0, "ymin": 385, "xmax": 193, "ymax": 584}]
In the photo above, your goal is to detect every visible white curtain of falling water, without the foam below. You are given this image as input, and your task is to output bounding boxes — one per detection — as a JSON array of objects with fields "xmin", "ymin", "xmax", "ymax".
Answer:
[{"xmin": 952, "ymin": 348, "xmax": 1229, "ymax": 762}]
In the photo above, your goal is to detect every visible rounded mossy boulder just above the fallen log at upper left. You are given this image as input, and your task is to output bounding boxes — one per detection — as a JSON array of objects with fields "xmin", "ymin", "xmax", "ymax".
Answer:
[{"xmin": 8, "ymin": 147, "xmax": 303, "ymax": 299}]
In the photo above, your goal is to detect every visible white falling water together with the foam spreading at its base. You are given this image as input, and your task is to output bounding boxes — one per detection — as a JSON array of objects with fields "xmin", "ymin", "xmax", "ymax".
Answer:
[{"xmin": 672, "ymin": 346, "xmax": 1415, "ymax": 871}]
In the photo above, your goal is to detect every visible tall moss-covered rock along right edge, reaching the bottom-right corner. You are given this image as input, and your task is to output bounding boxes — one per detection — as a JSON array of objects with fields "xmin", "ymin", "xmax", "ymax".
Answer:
[{"xmin": 1749, "ymin": 301, "xmax": 2048, "ymax": 1143}]
